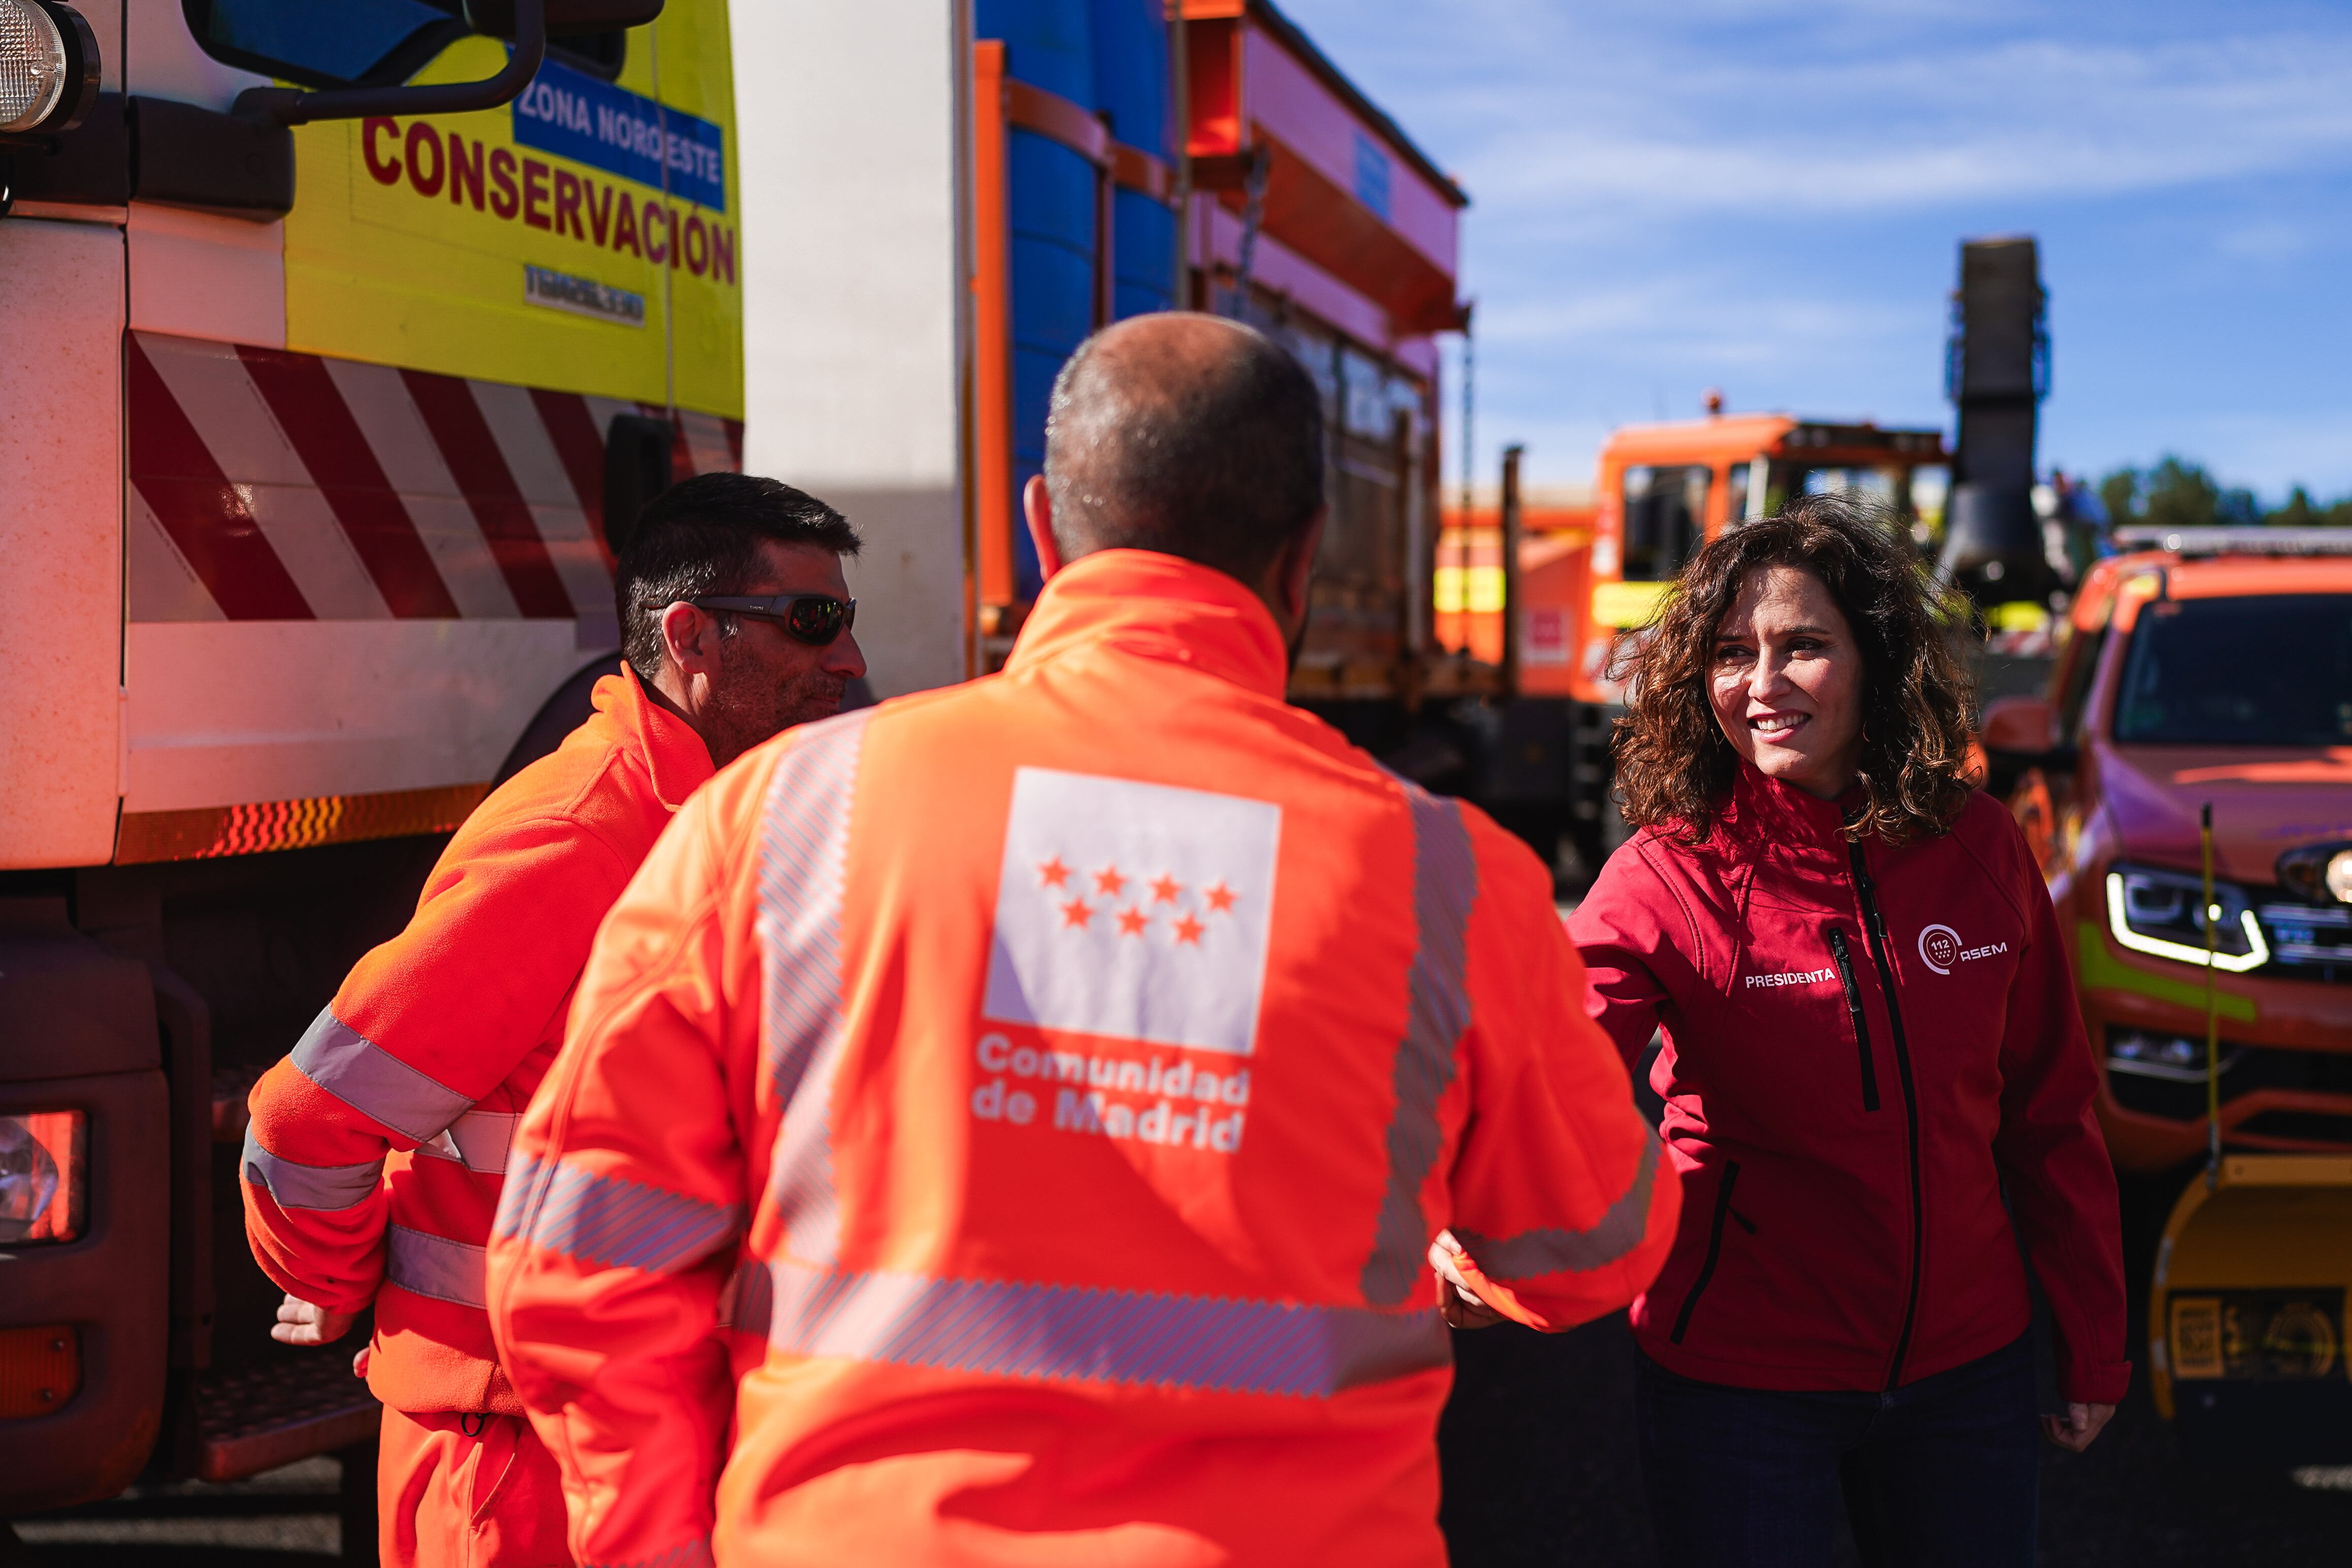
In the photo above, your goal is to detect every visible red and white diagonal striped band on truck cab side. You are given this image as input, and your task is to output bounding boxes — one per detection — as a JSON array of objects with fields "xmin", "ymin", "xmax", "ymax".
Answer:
[{"xmin": 122, "ymin": 332, "xmax": 743, "ymax": 623}]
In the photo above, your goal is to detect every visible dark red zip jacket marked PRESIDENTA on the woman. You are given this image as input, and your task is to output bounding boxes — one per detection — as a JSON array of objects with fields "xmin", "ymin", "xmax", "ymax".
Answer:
[{"xmin": 1569, "ymin": 766, "xmax": 2131, "ymax": 1403}]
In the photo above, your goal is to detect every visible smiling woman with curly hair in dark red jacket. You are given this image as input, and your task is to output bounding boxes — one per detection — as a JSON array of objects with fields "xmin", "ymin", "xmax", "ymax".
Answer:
[{"xmin": 1569, "ymin": 496, "xmax": 2131, "ymax": 1568}]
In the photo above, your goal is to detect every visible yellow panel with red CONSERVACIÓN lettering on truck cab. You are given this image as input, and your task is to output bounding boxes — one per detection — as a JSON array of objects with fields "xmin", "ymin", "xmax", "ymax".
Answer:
[{"xmin": 284, "ymin": 0, "xmax": 743, "ymax": 419}]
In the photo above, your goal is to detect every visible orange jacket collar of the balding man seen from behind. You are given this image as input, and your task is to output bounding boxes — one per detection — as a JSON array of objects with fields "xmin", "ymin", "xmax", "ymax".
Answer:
[{"xmin": 1004, "ymin": 550, "xmax": 1289, "ymax": 698}]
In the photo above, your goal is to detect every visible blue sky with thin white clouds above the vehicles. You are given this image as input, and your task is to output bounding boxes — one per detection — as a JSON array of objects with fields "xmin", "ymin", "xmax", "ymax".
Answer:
[{"xmin": 1280, "ymin": 0, "xmax": 2352, "ymax": 501}]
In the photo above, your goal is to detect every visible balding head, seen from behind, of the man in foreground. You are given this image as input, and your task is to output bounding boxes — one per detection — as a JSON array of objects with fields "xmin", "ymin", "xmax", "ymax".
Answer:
[{"xmin": 1044, "ymin": 310, "xmax": 1324, "ymax": 583}]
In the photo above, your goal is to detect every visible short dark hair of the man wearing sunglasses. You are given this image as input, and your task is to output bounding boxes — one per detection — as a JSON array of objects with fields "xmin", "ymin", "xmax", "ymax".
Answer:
[{"xmin": 612, "ymin": 472, "xmax": 866, "ymax": 682}]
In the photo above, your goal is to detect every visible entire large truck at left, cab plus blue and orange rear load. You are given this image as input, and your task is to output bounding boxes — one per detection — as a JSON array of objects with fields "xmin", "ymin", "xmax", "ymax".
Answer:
[{"xmin": 0, "ymin": 0, "xmax": 1468, "ymax": 1532}]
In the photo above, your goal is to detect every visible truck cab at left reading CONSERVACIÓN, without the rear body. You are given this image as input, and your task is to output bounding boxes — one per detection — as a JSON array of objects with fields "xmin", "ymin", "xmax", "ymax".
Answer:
[{"xmin": 0, "ymin": 0, "xmax": 743, "ymax": 1516}]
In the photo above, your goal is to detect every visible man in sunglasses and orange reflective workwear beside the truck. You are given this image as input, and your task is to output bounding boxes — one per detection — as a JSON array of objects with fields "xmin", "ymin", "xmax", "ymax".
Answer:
[{"xmin": 245, "ymin": 472, "xmax": 866, "ymax": 1568}]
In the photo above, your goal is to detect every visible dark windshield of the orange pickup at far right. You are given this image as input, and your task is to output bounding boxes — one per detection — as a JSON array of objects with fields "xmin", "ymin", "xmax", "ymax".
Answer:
[{"xmin": 2114, "ymin": 592, "xmax": 2352, "ymax": 745}]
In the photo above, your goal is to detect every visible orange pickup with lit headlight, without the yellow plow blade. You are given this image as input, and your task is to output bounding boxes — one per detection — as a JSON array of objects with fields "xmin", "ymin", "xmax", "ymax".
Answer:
[{"xmin": 1983, "ymin": 529, "xmax": 2352, "ymax": 1173}]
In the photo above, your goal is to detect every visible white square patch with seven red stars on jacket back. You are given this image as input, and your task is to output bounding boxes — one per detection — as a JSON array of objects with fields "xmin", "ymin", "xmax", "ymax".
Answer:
[{"xmin": 981, "ymin": 769, "xmax": 1282, "ymax": 1055}]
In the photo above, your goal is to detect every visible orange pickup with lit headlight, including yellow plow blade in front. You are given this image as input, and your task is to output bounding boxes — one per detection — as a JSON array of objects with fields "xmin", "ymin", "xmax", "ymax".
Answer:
[{"xmin": 1983, "ymin": 529, "xmax": 2352, "ymax": 1464}]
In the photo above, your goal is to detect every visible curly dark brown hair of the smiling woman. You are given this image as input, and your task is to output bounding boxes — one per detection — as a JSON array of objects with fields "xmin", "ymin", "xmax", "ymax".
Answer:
[{"xmin": 1611, "ymin": 494, "xmax": 1974, "ymax": 844}]
